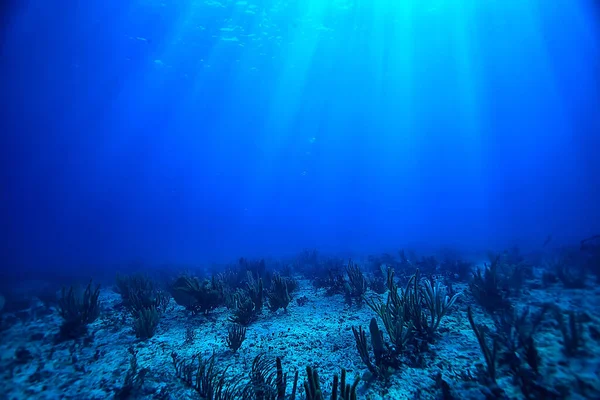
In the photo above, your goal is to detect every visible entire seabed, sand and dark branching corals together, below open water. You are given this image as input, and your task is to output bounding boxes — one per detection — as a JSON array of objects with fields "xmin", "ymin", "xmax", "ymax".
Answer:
[{"xmin": 0, "ymin": 238, "xmax": 600, "ymax": 400}]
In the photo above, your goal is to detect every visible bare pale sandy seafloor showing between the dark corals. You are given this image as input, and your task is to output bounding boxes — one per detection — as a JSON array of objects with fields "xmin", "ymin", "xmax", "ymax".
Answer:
[{"xmin": 0, "ymin": 270, "xmax": 600, "ymax": 400}]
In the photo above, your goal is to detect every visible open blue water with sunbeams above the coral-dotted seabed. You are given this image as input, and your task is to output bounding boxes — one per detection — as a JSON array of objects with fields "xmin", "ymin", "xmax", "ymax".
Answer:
[{"xmin": 1, "ymin": 0, "xmax": 600, "ymax": 266}]
